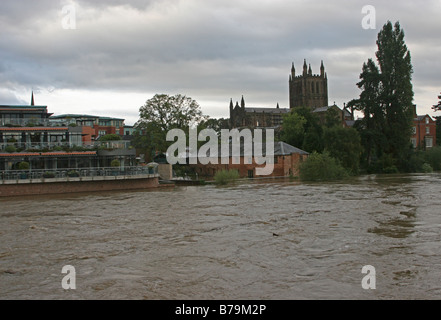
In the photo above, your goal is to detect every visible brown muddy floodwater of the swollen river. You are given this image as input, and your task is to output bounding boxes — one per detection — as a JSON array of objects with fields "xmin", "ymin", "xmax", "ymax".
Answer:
[{"xmin": 0, "ymin": 174, "xmax": 441, "ymax": 300}]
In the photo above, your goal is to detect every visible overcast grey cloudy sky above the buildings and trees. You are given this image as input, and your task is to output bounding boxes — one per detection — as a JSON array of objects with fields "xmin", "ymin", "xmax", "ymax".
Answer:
[{"xmin": 0, "ymin": 0, "xmax": 441, "ymax": 125}]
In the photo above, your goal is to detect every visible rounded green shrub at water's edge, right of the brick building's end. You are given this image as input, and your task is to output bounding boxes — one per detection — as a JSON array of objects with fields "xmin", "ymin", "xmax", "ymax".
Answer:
[{"xmin": 299, "ymin": 152, "xmax": 349, "ymax": 181}]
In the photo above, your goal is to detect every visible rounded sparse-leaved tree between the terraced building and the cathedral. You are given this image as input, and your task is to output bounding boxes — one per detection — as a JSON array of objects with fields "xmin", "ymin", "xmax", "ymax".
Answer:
[{"xmin": 133, "ymin": 94, "xmax": 207, "ymax": 157}]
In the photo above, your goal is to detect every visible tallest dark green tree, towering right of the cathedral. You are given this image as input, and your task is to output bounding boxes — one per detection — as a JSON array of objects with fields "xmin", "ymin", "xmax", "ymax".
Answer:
[{"xmin": 349, "ymin": 21, "xmax": 413, "ymax": 168}]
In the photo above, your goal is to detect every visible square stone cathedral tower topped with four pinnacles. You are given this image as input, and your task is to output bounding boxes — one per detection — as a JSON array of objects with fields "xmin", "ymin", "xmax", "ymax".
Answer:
[{"xmin": 289, "ymin": 59, "xmax": 328, "ymax": 110}]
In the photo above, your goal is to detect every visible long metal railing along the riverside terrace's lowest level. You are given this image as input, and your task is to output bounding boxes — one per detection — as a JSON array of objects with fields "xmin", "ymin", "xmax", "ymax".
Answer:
[{"xmin": 0, "ymin": 166, "xmax": 158, "ymax": 181}]
